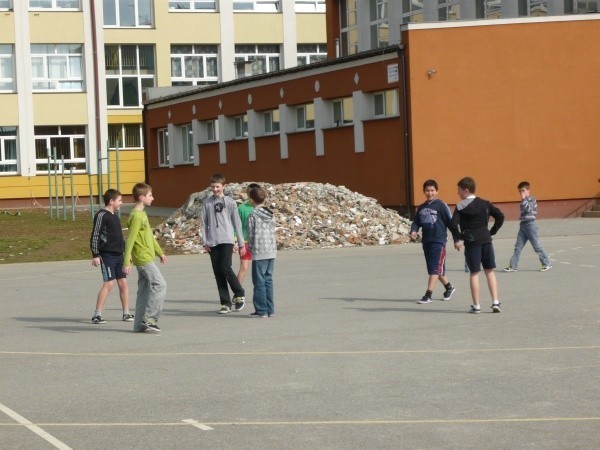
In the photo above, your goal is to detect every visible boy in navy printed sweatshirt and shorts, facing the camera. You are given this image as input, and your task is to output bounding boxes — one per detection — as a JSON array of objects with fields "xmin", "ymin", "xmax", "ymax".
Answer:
[{"xmin": 410, "ymin": 180, "xmax": 456, "ymax": 304}]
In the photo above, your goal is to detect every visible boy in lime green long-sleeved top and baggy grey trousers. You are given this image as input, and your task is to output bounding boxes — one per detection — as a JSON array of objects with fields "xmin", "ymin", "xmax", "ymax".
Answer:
[{"xmin": 123, "ymin": 183, "xmax": 167, "ymax": 333}]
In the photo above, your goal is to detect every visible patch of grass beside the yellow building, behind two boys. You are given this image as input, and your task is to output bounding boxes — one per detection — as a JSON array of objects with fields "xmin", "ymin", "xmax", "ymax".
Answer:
[{"xmin": 0, "ymin": 208, "xmax": 175, "ymax": 264}]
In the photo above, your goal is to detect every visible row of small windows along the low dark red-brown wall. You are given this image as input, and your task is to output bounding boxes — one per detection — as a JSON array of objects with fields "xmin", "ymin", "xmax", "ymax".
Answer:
[{"xmin": 157, "ymin": 90, "xmax": 398, "ymax": 167}]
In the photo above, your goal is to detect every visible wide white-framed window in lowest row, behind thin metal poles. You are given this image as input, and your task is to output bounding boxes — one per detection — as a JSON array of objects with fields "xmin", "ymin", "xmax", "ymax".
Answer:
[{"xmin": 33, "ymin": 125, "xmax": 87, "ymax": 173}]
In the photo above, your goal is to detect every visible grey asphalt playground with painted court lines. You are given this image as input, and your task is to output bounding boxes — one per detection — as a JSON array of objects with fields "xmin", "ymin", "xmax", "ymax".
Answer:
[{"xmin": 0, "ymin": 219, "xmax": 600, "ymax": 449}]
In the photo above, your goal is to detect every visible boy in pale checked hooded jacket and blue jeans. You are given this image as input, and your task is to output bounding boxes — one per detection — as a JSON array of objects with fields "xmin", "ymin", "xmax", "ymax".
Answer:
[{"xmin": 248, "ymin": 187, "xmax": 277, "ymax": 318}]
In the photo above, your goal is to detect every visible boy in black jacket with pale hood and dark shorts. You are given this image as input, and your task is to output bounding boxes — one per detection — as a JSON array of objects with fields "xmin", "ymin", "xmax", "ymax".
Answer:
[{"xmin": 452, "ymin": 177, "xmax": 504, "ymax": 314}]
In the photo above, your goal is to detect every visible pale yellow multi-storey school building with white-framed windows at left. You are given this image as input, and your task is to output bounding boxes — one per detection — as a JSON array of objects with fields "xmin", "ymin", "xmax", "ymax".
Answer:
[{"xmin": 0, "ymin": 0, "xmax": 327, "ymax": 207}]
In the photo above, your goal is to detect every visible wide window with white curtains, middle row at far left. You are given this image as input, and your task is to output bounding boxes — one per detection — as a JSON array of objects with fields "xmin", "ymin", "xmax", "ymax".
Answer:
[{"xmin": 31, "ymin": 44, "xmax": 83, "ymax": 92}]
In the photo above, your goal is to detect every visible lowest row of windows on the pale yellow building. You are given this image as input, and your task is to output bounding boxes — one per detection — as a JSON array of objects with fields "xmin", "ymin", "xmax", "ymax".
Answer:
[{"xmin": 0, "ymin": 124, "xmax": 142, "ymax": 175}]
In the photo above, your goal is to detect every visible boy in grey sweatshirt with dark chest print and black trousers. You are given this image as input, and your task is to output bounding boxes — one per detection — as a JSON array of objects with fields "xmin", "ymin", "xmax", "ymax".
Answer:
[{"xmin": 200, "ymin": 173, "xmax": 246, "ymax": 314}]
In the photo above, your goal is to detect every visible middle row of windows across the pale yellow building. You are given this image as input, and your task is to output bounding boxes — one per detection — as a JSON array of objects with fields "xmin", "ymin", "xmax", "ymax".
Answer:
[{"xmin": 0, "ymin": 44, "xmax": 327, "ymax": 108}]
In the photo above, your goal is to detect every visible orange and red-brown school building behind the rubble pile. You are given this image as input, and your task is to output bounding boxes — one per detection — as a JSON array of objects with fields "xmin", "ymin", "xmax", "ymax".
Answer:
[{"xmin": 143, "ymin": 0, "xmax": 600, "ymax": 219}]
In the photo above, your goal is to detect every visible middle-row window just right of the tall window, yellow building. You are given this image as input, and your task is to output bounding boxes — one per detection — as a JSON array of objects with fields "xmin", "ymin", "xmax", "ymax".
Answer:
[{"xmin": 171, "ymin": 45, "xmax": 219, "ymax": 86}]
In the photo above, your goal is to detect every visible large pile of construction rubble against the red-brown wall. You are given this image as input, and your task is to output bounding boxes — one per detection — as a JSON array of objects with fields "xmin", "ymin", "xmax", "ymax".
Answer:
[{"xmin": 155, "ymin": 183, "xmax": 411, "ymax": 253}]
